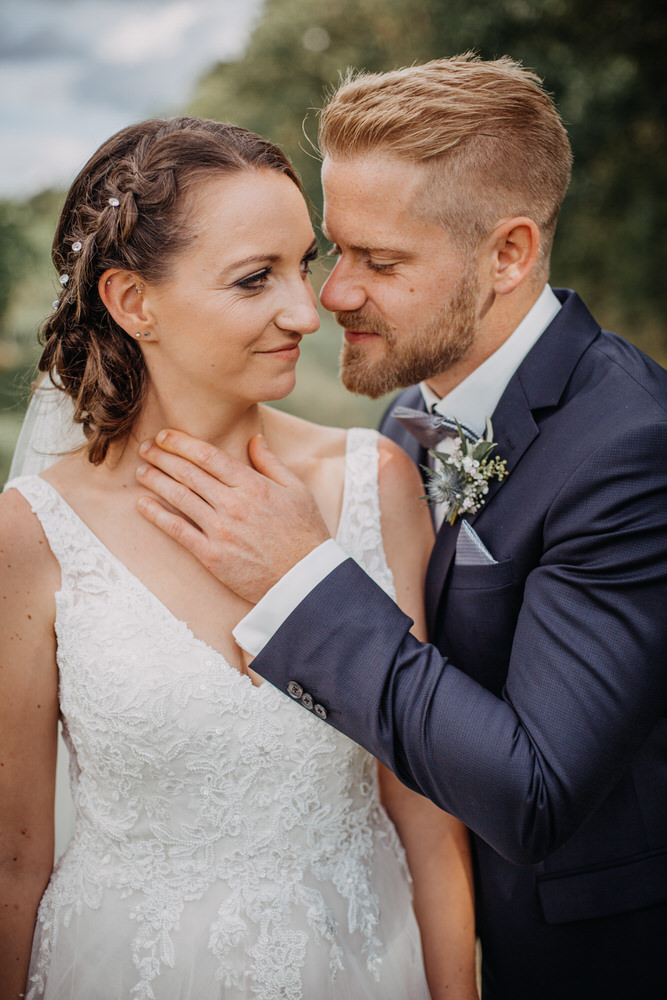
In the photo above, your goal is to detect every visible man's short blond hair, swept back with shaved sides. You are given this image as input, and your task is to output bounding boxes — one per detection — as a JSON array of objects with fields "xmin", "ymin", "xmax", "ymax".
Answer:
[{"xmin": 319, "ymin": 53, "xmax": 572, "ymax": 261}]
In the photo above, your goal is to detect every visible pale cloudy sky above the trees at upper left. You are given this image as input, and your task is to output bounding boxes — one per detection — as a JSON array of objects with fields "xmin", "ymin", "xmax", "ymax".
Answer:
[{"xmin": 0, "ymin": 0, "xmax": 262, "ymax": 198}]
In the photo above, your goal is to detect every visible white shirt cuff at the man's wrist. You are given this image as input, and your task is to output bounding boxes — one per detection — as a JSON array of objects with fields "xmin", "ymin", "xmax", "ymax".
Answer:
[{"xmin": 232, "ymin": 538, "xmax": 348, "ymax": 656}]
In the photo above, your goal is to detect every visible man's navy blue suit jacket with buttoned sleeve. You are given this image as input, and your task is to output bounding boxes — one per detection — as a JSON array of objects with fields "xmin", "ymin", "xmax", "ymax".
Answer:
[{"xmin": 253, "ymin": 291, "xmax": 667, "ymax": 1000}]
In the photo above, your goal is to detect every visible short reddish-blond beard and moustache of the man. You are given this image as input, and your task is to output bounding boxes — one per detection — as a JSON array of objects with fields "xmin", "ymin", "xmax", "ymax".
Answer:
[{"xmin": 335, "ymin": 276, "xmax": 479, "ymax": 399}]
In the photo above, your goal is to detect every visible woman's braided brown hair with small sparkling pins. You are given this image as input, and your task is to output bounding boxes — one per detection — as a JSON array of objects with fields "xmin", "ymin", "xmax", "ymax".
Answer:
[{"xmin": 39, "ymin": 117, "xmax": 302, "ymax": 465}]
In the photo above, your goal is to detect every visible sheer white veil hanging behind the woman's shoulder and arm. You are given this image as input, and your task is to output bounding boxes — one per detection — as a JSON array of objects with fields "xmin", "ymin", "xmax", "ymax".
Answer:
[{"xmin": 9, "ymin": 377, "xmax": 85, "ymax": 859}]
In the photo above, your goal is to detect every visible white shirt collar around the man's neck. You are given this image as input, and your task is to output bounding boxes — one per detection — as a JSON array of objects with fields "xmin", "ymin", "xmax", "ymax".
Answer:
[{"xmin": 419, "ymin": 285, "xmax": 561, "ymax": 435}]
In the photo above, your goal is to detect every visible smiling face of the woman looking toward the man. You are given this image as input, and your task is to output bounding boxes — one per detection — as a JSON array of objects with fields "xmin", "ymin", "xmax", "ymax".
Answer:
[{"xmin": 143, "ymin": 170, "xmax": 319, "ymax": 405}]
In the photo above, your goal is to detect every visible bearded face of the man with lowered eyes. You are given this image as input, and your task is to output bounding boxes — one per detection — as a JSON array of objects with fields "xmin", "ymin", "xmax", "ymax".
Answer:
[{"xmin": 320, "ymin": 154, "xmax": 481, "ymax": 398}]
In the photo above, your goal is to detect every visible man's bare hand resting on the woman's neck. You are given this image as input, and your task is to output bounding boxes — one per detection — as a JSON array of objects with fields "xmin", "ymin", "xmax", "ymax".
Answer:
[{"xmin": 137, "ymin": 430, "xmax": 330, "ymax": 604}]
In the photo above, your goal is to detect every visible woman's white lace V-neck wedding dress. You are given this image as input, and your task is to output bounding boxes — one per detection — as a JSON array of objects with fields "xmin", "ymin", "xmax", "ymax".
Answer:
[{"xmin": 7, "ymin": 429, "xmax": 428, "ymax": 1000}]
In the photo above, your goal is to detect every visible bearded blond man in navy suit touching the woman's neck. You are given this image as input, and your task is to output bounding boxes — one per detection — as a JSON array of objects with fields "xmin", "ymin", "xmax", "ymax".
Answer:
[{"xmin": 140, "ymin": 57, "xmax": 667, "ymax": 1000}]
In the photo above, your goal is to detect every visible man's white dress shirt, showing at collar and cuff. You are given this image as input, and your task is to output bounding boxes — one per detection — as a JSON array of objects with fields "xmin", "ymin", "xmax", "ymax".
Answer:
[{"xmin": 233, "ymin": 285, "xmax": 561, "ymax": 656}]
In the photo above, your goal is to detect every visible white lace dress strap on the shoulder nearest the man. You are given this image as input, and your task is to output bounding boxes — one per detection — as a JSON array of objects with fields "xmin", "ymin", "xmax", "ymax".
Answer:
[{"xmin": 337, "ymin": 427, "xmax": 396, "ymax": 600}]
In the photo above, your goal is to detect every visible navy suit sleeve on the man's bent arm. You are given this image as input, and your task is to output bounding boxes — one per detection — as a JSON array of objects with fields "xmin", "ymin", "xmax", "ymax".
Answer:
[{"xmin": 253, "ymin": 424, "xmax": 667, "ymax": 863}]
